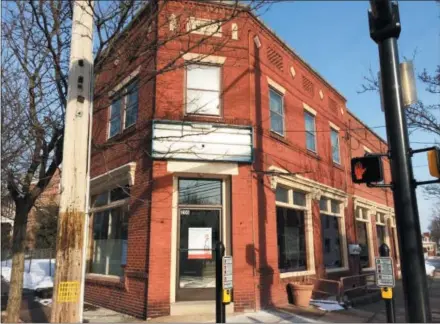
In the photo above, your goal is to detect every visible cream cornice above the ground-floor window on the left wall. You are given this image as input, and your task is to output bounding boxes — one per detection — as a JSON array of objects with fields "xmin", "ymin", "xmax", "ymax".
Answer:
[{"xmin": 90, "ymin": 162, "xmax": 136, "ymax": 195}]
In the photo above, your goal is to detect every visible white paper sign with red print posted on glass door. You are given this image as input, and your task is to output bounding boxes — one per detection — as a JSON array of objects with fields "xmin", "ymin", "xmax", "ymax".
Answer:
[{"xmin": 188, "ymin": 227, "xmax": 212, "ymax": 260}]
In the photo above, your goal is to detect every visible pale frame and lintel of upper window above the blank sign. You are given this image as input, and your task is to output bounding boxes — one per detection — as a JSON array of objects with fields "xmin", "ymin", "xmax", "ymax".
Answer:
[{"xmin": 184, "ymin": 63, "xmax": 224, "ymax": 117}]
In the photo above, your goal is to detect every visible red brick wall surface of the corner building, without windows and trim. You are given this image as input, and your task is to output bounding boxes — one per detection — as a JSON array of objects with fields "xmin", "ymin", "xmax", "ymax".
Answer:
[{"xmin": 86, "ymin": 2, "xmax": 392, "ymax": 317}]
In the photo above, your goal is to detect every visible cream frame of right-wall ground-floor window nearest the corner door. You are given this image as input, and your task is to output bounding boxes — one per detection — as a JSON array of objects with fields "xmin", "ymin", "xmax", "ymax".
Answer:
[{"xmin": 275, "ymin": 178, "xmax": 316, "ymax": 278}]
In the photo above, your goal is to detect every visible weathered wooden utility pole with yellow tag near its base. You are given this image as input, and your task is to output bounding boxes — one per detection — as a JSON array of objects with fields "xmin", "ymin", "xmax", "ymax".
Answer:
[{"xmin": 51, "ymin": 0, "xmax": 93, "ymax": 323}]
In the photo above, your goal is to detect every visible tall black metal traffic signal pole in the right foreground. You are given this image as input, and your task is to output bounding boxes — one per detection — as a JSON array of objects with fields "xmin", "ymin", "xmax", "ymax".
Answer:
[{"xmin": 368, "ymin": 0, "xmax": 431, "ymax": 322}]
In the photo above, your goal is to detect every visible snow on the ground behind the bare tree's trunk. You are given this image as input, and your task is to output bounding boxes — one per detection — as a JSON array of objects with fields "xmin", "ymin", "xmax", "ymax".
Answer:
[{"xmin": 1, "ymin": 259, "xmax": 55, "ymax": 290}]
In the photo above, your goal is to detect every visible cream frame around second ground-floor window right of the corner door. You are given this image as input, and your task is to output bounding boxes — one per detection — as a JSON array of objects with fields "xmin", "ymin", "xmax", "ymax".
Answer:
[{"xmin": 319, "ymin": 193, "xmax": 349, "ymax": 273}]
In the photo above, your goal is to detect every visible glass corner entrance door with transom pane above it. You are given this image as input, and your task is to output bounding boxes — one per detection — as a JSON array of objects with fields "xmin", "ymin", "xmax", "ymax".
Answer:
[{"xmin": 176, "ymin": 179, "xmax": 222, "ymax": 301}]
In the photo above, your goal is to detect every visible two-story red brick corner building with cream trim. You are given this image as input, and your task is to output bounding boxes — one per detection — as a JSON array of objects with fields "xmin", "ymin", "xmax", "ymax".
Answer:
[{"xmin": 86, "ymin": 1, "xmax": 398, "ymax": 318}]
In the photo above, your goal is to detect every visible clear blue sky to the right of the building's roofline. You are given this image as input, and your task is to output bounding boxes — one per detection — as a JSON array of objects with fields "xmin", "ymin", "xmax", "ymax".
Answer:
[{"xmin": 261, "ymin": 1, "xmax": 440, "ymax": 230}]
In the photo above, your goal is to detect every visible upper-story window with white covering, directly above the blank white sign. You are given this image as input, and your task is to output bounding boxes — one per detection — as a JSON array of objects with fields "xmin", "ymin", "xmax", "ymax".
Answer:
[{"xmin": 186, "ymin": 64, "xmax": 221, "ymax": 116}]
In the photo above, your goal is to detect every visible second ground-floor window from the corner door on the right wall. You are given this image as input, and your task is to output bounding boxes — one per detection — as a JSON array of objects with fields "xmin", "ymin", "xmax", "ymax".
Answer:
[{"xmin": 319, "ymin": 197, "xmax": 345, "ymax": 269}]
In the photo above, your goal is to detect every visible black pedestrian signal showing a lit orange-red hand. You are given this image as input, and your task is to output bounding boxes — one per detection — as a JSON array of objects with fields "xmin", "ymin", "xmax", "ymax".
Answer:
[{"xmin": 351, "ymin": 156, "xmax": 383, "ymax": 183}]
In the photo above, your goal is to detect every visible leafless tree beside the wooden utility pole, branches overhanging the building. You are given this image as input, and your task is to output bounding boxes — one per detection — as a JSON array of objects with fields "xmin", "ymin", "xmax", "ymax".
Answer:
[{"xmin": 1, "ymin": 0, "xmax": 264, "ymax": 322}]
